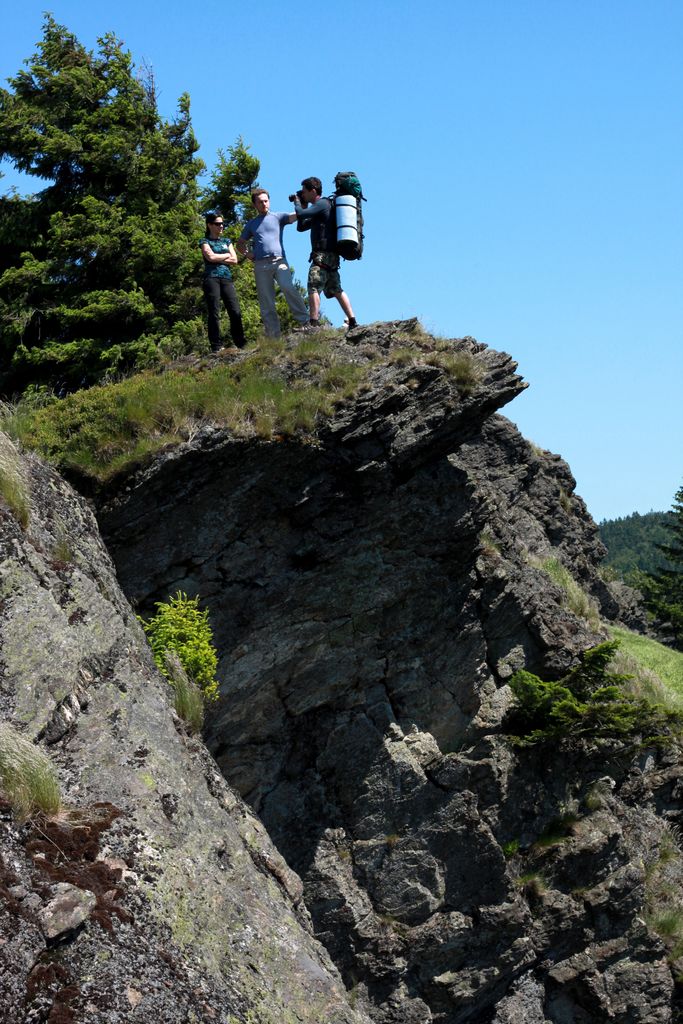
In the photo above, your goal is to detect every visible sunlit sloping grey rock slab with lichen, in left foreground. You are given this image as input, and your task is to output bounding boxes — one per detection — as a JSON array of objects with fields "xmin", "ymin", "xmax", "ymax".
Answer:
[{"xmin": 0, "ymin": 438, "xmax": 367, "ymax": 1024}]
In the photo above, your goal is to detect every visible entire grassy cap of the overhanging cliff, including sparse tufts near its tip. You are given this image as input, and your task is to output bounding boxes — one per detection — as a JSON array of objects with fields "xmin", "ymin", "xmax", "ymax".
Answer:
[{"xmin": 0, "ymin": 328, "xmax": 483, "ymax": 483}]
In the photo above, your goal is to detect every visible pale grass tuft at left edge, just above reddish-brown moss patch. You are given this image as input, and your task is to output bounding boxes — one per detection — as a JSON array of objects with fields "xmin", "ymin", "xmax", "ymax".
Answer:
[{"xmin": 0, "ymin": 723, "xmax": 61, "ymax": 820}]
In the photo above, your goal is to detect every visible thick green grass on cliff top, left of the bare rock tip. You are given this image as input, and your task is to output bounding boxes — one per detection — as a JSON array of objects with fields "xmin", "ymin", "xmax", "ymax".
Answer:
[{"xmin": 3, "ymin": 344, "xmax": 365, "ymax": 481}]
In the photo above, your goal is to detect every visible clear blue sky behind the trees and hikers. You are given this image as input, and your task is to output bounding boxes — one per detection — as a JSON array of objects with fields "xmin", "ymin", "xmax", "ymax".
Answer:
[{"xmin": 0, "ymin": 0, "xmax": 683, "ymax": 520}]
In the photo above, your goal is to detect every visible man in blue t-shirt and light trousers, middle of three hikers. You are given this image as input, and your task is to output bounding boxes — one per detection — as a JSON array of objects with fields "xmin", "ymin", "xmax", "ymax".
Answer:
[{"xmin": 238, "ymin": 188, "xmax": 308, "ymax": 338}]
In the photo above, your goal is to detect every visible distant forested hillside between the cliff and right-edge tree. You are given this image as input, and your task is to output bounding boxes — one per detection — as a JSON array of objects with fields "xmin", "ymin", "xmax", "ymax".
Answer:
[{"xmin": 598, "ymin": 512, "xmax": 672, "ymax": 581}]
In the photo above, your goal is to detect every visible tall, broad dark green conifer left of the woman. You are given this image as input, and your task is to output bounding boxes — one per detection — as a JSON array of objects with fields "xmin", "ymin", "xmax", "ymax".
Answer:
[{"xmin": 0, "ymin": 15, "xmax": 203, "ymax": 391}]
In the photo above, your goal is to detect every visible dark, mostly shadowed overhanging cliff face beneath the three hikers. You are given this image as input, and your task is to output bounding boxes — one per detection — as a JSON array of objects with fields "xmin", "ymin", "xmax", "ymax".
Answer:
[{"xmin": 93, "ymin": 325, "xmax": 680, "ymax": 1024}]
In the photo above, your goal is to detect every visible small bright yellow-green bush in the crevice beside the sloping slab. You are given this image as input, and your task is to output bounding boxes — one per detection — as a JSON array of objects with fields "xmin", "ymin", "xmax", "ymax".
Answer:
[{"xmin": 142, "ymin": 591, "xmax": 218, "ymax": 700}]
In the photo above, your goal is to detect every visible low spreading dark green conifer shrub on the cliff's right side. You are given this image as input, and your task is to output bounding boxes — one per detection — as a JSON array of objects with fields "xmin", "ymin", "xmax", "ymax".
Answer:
[{"xmin": 506, "ymin": 641, "xmax": 683, "ymax": 745}]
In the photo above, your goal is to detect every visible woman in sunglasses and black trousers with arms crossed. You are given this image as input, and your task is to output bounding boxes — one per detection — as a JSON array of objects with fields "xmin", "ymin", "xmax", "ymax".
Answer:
[{"xmin": 200, "ymin": 213, "xmax": 247, "ymax": 352}]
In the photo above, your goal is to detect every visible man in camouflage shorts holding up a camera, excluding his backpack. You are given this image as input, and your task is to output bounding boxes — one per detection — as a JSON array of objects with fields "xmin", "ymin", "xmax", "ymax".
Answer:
[{"xmin": 293, "ymin": 177, "xmax": 357, "ymax": 328}]
